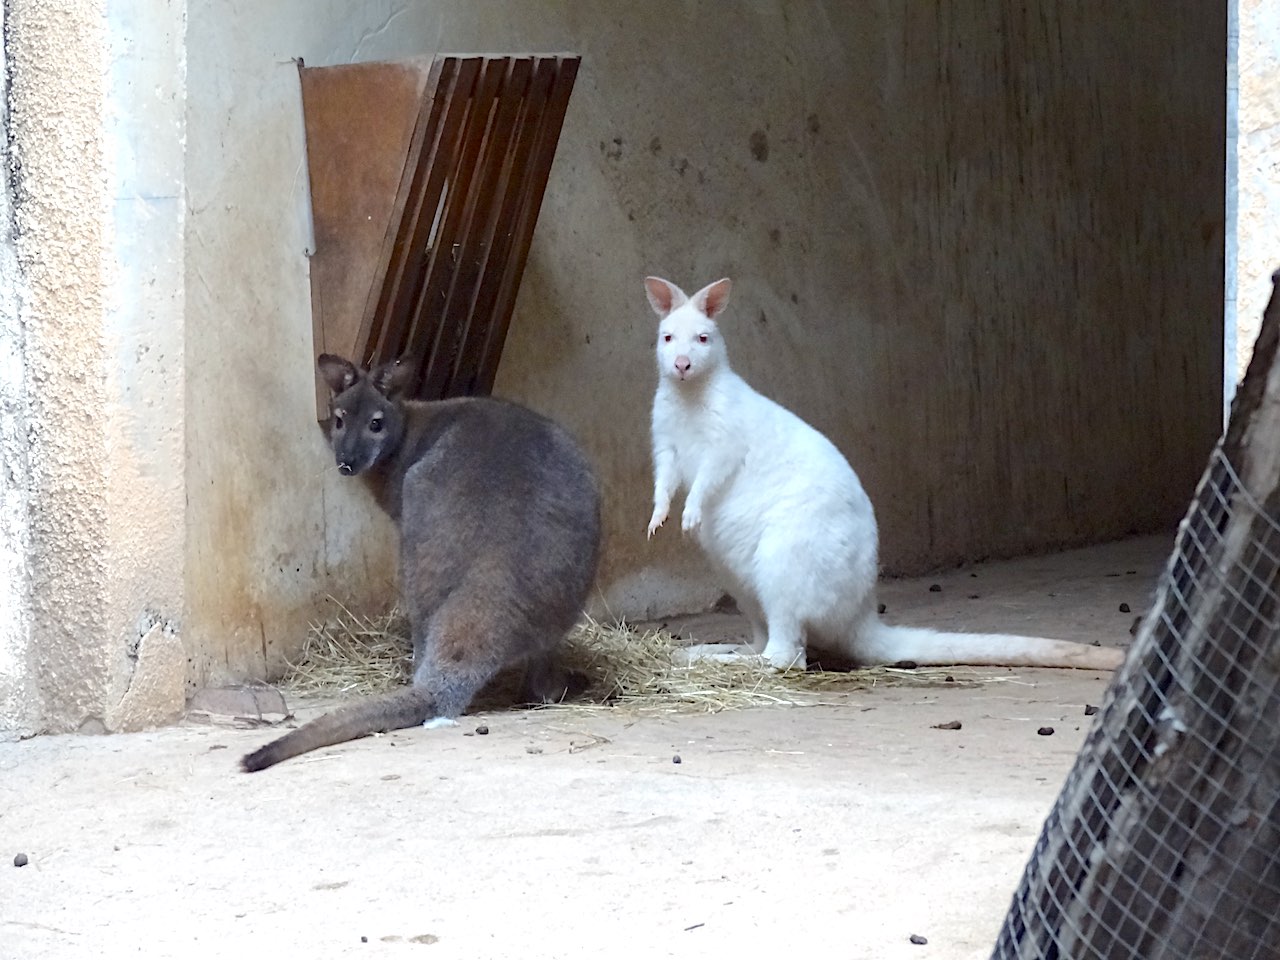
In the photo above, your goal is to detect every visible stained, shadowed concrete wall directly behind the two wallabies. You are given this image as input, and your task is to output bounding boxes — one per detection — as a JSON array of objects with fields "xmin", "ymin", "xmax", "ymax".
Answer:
[{"xmin": 177, "ymin": 0, "xmax": 1225, "ymax": 684}]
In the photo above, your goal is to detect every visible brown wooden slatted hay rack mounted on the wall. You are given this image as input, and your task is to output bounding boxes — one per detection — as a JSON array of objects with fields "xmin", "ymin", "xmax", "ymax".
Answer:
[{"xmin": 300, "ymin": 55, "xmax": 581, "ymax": 419}]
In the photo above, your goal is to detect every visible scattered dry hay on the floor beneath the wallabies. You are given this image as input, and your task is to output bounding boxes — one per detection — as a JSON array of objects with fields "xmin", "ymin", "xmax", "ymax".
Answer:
[{"xmin": 284, "ymin": 604, "xmax": 1011, "ymax": 713}]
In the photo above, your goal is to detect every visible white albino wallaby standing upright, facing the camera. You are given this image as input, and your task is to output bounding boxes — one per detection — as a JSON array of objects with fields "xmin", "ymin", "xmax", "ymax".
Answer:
[{"xmin": 645, "ymin": 276, "xmax": 1124, "ymax": 669}]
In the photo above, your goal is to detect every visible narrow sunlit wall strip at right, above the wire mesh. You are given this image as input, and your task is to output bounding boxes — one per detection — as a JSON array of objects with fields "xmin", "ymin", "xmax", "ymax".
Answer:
[{"xmin": 1228, "ymin": 0, "xmax": 1280, "ymax": 379}]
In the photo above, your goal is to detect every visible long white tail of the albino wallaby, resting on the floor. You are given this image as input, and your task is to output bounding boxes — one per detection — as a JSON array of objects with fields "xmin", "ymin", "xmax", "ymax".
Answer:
[{"xmin": 855, "ymin": 618, "xmax": 1125, "ymax": 669}]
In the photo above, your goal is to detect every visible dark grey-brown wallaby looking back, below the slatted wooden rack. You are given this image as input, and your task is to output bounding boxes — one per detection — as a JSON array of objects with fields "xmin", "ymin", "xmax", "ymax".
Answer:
[{"xmin": 241, "ymin": 353, "xmax": 600, "ymax": 771}]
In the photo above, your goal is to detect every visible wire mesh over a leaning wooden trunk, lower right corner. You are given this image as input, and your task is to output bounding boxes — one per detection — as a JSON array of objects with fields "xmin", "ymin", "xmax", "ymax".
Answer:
[{"xmin": 992, "ymin": 272, "xmax": 1280, "ymax": 960}]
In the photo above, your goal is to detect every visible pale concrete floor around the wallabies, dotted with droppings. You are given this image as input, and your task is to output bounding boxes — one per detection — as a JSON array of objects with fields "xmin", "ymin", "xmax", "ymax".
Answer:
[{"xmin": 0, "ymin": 538, "xmax": 1171, "ymax": 960}]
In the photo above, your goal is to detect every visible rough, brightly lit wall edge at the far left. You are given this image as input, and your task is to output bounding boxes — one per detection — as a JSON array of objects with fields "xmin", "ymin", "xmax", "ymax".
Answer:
[{"xmin": 0, "ymin": 0, "xmax": 186, "ymax": 735}]
